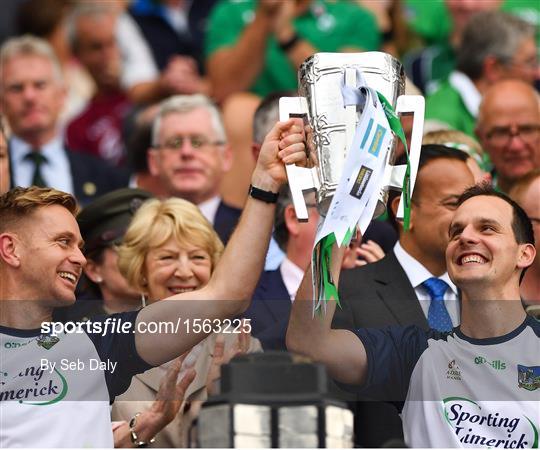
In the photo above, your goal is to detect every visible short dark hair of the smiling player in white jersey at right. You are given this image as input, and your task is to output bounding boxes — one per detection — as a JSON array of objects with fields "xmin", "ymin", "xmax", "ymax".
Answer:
[{"xmin": 457, "ymin": 183, "xmax": 535, "ymax": 245}]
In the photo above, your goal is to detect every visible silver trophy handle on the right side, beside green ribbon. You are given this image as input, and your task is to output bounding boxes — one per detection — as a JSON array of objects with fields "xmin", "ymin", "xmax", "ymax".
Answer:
[{"xmin": 389, "ymin": 95, "xmax": 425, "ymax": 219}]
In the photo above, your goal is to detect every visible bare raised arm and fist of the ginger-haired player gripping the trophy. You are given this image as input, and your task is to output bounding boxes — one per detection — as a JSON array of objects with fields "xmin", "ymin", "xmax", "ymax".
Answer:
[{"xmin": 135, "ymin": 119, "xmax": 306, "ymax": 365}]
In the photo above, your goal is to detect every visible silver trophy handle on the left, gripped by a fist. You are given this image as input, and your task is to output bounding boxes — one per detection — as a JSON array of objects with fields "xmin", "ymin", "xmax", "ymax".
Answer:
[{"xmin": 279, "ymin": 97, "xmax": 319, "ymax": 222}]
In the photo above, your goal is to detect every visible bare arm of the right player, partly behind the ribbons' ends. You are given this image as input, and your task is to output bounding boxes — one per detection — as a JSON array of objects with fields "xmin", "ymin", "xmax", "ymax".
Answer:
[{"xmin": 287, "ymin": 232, "xmax": 367, "ymax": 385}]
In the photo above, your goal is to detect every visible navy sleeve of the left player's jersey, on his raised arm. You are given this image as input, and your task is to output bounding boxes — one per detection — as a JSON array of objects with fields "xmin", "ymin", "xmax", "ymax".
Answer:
[{"xmin": 83, "ymin": 311, "xmax": 153, "ymax": 403}]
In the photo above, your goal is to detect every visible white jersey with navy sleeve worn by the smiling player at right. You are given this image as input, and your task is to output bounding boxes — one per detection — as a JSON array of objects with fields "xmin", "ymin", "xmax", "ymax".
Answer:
[{"xmin": 350, "ymin": 317, "xmax": 540, "ymax": 448}]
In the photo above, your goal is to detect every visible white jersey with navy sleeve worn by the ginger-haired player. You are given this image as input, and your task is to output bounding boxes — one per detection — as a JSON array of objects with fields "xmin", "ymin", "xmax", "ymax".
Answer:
[{"xmin": 0, "ymin": 312, "xmax": 151, "ymax": 448}]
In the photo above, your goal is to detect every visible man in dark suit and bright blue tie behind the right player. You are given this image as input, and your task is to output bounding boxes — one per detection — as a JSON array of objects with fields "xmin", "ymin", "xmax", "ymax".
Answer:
[{"xmin": 333, "ymin": 145, "xmax": 474, "ymax": 447}]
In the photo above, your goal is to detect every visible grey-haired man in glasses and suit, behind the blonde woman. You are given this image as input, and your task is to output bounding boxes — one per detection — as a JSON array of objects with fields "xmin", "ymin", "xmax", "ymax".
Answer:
[{"xmin": 148, "ymin": 94, "xmax": 241, "ymax": 243}]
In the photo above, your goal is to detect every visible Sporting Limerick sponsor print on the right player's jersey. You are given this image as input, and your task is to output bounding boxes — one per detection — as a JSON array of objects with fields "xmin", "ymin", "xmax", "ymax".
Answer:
[{"xmin": 443, "ymin": 397, "xmax": 538, "ymax": 448}]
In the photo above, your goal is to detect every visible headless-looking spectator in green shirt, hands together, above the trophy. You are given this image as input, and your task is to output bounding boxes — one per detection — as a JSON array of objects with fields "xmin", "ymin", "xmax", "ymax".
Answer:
[{"xmin": 206, "ymin": 0, "xmax": 380, "ymax": 101}]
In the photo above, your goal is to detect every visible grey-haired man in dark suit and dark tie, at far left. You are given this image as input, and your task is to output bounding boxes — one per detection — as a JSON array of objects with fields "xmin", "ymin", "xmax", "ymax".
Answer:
[{"xmin": 0, "ymin": 36, "xmax": 128, "ymax": 204}]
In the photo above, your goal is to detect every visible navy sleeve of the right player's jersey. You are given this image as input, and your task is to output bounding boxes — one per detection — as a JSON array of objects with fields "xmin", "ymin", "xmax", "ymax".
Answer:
[{"xmin": 343, "ymin": 326, "xmax": 428, "ymax": 404}]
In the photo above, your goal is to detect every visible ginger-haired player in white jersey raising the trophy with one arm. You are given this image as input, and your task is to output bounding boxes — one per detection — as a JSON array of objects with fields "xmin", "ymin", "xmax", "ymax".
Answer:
[{"xmin": 0, "ymin": 119, "xmax": 305, "ymax": 447}]
